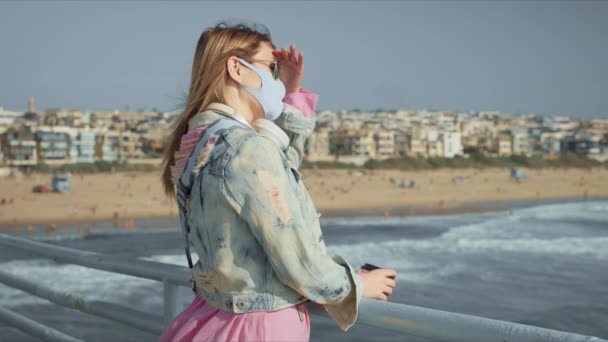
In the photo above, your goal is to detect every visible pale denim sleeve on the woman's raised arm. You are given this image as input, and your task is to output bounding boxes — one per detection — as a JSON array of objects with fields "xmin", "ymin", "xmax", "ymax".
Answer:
[{"xmin": 274, "ymin": 103, "xmax": 316, "ymax": 168}]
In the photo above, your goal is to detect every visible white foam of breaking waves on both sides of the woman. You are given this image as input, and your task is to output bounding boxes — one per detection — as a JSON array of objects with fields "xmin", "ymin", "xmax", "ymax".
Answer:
[{"xmin": 0, "ymin": 202, "xmax": 608, "ymax": 307}]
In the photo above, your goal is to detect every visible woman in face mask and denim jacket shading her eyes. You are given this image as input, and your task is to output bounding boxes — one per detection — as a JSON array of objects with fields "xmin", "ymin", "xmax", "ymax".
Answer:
[{"xmin": 160, "ymin": 23, "xmax": 396, "ymax": 342}]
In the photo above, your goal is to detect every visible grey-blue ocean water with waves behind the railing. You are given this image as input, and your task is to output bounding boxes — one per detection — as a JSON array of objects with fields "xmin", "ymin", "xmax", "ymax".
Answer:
[{"xmin": 0, "ymin": 201, "xmax": 608, "ymax": 341}]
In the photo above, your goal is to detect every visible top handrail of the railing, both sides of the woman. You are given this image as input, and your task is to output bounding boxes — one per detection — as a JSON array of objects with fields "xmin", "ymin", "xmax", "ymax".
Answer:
[{"xmin": 0, "ymin": 233, "xmax": 608, "ymax": 342}]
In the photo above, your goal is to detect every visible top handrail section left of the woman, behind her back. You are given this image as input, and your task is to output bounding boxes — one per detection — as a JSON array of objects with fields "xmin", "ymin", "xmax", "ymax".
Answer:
[{"xmin": 0, "ymin": 233, "xmax": 190, "ymax": 286}]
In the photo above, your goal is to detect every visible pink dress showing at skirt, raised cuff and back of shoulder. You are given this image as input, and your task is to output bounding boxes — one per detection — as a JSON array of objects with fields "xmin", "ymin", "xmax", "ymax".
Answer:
[{"xmin": 160, "ymin": 88, "xmax": 319, "ymax": 342}]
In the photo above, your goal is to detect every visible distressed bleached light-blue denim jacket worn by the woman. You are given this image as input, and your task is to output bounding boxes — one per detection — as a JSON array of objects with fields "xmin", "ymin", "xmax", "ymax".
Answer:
[{"xmin": 171, "ymin": 103, "xmax": 363, "ymax": 331}]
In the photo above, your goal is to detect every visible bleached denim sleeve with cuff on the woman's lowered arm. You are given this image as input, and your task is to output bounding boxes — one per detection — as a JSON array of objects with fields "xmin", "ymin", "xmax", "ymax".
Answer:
[{"xmin": 222, "ymin": 135, "xmax": 363, "ymax": 331}]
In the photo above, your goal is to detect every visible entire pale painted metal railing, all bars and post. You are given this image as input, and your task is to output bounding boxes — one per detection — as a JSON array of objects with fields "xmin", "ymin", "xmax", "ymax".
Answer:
[{"xmin": 0, "ymin": 233, "xmax": 607, "ymax": 342}]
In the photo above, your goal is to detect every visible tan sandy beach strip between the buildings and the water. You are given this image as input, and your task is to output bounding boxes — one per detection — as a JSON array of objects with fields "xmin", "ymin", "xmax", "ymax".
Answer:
[{"xmin": 0, "ymin": 168, "xmax": 608, "ymax": 227}]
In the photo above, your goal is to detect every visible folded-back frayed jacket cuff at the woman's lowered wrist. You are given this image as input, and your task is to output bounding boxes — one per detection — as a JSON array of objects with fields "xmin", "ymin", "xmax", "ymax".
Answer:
[{"xmin": 323, "ymin": 255, "xmax": 363, "ymax": 331}]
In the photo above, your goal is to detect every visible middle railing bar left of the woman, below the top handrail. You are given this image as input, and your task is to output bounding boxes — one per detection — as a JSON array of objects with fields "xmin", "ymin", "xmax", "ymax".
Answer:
[{"xmin": 0, "ymin": 270, "xmax": 163, "ymax": 334}]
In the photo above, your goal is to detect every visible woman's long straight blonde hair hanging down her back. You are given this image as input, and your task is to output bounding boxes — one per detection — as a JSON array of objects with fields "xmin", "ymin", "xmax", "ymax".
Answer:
[{"xmin": 161, "ymin": 22, "xmax": 275, "ymax": 197}]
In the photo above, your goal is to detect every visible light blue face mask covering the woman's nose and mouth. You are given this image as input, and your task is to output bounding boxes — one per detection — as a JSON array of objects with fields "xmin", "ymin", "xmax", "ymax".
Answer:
[{"xmin": 239, "ymin": 58, "xmax": 285, "ymax": 121}]
